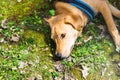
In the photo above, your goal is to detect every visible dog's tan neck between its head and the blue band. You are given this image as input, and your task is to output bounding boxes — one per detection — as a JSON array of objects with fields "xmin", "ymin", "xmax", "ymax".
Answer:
[{"xmin": 55, "ymin": 1, "xmax": 89, "ymax": 26}]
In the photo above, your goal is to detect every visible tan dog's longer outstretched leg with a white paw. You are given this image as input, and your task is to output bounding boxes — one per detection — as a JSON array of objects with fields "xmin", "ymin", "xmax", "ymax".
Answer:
[{"xmin": 99, "ymin": 2, "xmax": 120, "ymax": 52}]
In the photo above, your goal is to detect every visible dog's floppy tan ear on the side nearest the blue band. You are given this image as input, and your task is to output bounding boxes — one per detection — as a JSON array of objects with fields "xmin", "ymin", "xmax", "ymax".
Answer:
[{"xmin": 64, "ymin": 16, "xmax": 84, "ymax": 31}]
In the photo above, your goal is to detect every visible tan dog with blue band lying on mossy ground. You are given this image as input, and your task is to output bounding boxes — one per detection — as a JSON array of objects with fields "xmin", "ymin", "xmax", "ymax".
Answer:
[{"xmin": 45, "ymin": 0, "xmax": 120, "ymax": 59}]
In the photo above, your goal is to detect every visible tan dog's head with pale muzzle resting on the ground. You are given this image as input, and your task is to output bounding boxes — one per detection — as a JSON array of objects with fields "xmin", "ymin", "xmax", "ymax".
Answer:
[{"xmin": 45, "ymin": 1, "xmax": 84, "ymax": 58}]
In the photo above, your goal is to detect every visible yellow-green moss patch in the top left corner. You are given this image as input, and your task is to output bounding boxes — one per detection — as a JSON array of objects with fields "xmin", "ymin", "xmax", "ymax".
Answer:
[{"xmin": 0, "ymin": 0, "xmax": 44, "ymax": 18}]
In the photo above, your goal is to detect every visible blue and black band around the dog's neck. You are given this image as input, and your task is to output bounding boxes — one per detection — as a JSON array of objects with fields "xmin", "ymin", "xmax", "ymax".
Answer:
[{"xmin": 62, "ymin": 0, "xmax": 96, "ymax": 21}]
